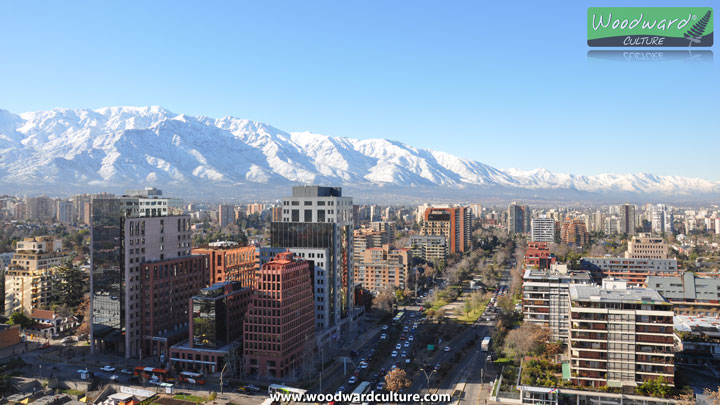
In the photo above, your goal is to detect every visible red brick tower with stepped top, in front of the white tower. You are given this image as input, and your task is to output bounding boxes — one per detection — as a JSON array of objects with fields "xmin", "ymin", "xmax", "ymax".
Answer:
[{"xmin": 243, "ymin": 252, "xmax": 315, "ymax": 377}]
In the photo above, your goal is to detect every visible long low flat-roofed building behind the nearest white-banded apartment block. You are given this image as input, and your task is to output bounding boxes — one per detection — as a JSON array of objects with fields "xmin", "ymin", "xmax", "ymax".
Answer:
[{"xmin": 580, "ymin": 256, "xmax": 678, "ymax": 287}]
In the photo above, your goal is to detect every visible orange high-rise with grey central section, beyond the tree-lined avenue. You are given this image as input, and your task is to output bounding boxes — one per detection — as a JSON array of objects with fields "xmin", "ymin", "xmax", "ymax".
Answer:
[{"xmin": 420, "ymin": 207, "xmax": 472, "ymax": 254}]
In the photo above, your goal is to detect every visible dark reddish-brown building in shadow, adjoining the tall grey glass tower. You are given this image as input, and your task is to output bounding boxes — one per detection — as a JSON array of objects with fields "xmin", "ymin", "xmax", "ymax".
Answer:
[{"xmin": 137, "ymin": 255, "xmax": 208, "ymax": 358}]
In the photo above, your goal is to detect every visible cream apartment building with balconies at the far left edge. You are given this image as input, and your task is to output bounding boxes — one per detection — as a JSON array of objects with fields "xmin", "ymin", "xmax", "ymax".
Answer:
[{"xmin": 3, "ymin": 236, "xmax": 70, "ymax": 316}]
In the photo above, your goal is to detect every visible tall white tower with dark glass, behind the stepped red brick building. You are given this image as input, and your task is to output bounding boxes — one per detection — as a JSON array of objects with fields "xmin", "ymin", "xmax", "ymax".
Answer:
[{"xmin": 270, "ymin": 186, "xmax": 355, "ymax": 341}]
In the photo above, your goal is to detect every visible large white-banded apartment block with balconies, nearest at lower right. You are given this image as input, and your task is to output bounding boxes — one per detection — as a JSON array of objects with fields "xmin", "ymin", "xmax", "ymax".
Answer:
[{"xmin": 569, "ymin": 279, "xmax": 675, "ymax": 387}]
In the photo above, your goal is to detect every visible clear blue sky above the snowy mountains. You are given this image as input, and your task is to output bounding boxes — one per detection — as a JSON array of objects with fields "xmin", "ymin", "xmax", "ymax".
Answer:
[{"xmin": 0, "ymin": 0, "xmax": 720, "ymax": 180}]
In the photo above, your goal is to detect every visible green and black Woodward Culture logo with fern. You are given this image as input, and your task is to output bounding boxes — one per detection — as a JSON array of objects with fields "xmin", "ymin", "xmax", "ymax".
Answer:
[{"xmin": 588, "ymin": 7, "xmax": 713, "ymax": 47}]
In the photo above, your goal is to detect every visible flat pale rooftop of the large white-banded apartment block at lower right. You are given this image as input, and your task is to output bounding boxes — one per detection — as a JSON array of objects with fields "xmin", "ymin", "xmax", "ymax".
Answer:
[{"xmin": 570, "ymin": 279, "xmax": 667, "ymax": 303}]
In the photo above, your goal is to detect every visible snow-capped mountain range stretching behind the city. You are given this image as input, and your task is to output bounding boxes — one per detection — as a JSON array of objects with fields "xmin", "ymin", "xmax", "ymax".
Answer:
[{"xmin": 0, "ymin": 106, "xmax": 720, "ymax": 196}]
